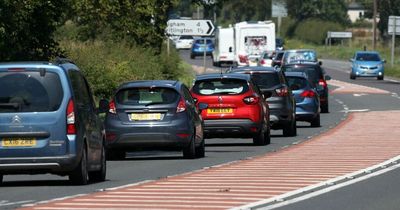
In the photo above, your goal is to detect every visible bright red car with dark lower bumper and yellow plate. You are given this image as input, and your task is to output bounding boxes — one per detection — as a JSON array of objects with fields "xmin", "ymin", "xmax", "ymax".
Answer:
[{"xmin": 191, "ymin": 73, "xmax": 271, "ymax": 145}]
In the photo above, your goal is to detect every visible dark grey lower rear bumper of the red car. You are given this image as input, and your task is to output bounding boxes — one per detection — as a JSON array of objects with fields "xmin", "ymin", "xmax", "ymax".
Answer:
[{"xmin": 204, "ymin": 119, "xmax": 261, "ymax": 138}]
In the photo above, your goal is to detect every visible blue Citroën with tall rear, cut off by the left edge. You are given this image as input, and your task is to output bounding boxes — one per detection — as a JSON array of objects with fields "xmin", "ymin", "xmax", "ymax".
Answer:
[{"xmin": 0, "ymin": 59, "xmax": 106, "ymax": 184}]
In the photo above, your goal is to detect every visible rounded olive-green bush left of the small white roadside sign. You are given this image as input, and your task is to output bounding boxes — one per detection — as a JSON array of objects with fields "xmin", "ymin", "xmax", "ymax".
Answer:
[{"xmin": 294, "ymin": 19, "xmax": 344, "ymax": 44}]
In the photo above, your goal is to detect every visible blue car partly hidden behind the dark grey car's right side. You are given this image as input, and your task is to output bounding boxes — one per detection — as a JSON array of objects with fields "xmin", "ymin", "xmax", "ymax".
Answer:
[{"xmin": 285, "ymin": 72, "xmax": 321, "ymax": 127}]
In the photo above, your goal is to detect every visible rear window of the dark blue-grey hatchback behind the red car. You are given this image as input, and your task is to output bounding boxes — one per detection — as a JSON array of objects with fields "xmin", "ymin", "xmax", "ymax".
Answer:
[{"xmin": 116, "ymin": 87, "xmax": 179, "ymax": 106}]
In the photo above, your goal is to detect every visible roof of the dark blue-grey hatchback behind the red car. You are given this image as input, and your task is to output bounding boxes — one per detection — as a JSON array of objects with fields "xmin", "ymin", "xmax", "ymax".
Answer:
[{"xmin": 118, "ymin": 80, "xmax": 181, "ymax": 90}]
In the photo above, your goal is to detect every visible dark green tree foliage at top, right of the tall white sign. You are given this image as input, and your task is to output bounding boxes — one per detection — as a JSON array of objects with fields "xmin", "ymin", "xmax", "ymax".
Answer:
[{"xmin": 287, "ymin": 0, "xmax": 349, "ymax": 25}]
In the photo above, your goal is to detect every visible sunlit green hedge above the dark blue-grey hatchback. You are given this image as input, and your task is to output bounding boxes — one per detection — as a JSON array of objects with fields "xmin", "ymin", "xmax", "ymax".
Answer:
[{"xmin": 61, "ymin": 41, "xmax": 191, "ymax": 98}]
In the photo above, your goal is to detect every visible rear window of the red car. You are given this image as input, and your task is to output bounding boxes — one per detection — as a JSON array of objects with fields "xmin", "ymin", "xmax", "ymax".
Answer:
[{"xmin": 193, "ymin": 78, "xmax": 249, "ymax": 95}]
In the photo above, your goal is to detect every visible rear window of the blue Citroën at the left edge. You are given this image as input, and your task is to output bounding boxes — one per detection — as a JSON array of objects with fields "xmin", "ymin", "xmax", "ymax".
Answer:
[{"xmin": 0, "ymin": 71, "xmax": 63, "ymax": 113}]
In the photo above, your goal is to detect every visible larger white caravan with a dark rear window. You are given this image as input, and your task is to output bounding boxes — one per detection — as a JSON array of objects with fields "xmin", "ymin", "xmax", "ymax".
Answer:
[{"xmin": 234, "ymin": 21, "xmax": 276, "ymax": 66}]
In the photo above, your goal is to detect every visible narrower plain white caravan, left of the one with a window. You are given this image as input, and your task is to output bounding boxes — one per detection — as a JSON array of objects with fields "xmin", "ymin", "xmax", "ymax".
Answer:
[{"xmin": 212, "ymin": 26, "xmax": 235, "ymax": 66}]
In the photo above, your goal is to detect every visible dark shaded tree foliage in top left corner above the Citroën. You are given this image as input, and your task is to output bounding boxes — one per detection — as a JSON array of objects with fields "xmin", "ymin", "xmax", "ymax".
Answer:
[{"xmin": 0, "ymin": 0, "xmax": 68, "ymax": 61}]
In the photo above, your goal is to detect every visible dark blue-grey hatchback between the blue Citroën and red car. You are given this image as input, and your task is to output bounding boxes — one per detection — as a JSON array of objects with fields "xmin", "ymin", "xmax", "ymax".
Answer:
[{"xmin": 102, "ymin": 80, "xmax": 206, "ymax": 159}]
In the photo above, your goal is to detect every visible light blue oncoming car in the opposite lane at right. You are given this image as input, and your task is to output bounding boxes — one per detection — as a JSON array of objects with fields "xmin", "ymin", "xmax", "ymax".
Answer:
[{"xmin": 350, "ymin": 51, "xmax": 386, "ymax": 80}]
